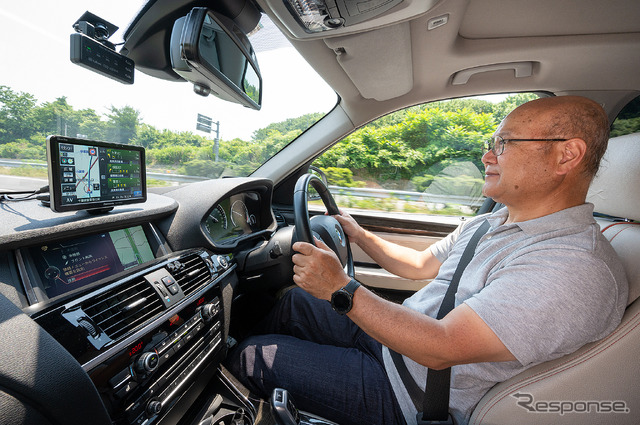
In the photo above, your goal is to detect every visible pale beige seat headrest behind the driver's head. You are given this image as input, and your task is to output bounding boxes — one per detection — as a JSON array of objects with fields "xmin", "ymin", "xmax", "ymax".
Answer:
[{"xmin": 587, "ymin": 133, "xmax": 640, "ymax": 220}]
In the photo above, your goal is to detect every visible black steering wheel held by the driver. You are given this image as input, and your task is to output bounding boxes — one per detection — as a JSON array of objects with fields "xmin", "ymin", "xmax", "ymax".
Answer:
[{"xmin": 293, "ymin": 174, "xmax": 355, "ymax": 277}]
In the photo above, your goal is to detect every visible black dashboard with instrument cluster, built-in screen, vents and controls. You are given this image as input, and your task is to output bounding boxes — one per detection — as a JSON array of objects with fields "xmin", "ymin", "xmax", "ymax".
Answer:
[{"xmin": 0, "ymin": 178, "xmax": 278, "ymax": 425}]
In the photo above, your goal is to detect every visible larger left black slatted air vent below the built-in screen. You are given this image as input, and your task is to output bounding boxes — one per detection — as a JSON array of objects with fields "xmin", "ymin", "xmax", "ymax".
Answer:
[{"xmin": 82, "ymin": 278, "xmax": 164, "ymax": 340}]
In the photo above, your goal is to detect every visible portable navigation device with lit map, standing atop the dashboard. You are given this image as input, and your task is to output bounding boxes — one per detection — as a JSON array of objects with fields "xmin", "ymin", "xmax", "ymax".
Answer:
[{"xmin": 47, "ymin": 136, "xmax": 147, "ymax": 212}]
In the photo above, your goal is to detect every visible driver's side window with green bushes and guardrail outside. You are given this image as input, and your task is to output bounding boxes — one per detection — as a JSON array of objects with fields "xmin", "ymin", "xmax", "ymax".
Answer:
[{"xmin": 313, "ymin": 93, "xmax": 538, "ymax": 216}]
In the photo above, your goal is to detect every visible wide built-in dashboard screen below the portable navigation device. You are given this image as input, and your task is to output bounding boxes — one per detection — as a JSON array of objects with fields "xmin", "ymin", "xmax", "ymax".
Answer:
[{"xmin": 30, "ymin": 226, "xmax": 155, "ymax": 298}]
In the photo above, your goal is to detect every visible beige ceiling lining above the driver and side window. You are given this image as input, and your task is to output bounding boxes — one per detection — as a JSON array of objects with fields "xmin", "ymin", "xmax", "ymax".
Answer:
[{"xmin": 258, "ymin": 0, "xmax": 640, "ymax": 127}]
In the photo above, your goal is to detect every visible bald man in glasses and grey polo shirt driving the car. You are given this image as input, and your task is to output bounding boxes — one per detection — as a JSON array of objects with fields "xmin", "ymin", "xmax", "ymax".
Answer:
[{"xmin": 230, "ymin": 96, "xmax": 628, "ymax": 424}]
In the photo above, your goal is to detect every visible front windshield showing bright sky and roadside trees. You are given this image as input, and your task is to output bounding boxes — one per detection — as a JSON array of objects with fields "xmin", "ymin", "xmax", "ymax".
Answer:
[{"xmin": 0, "ymin": 0, "xmax": 337, "ymax": 190}]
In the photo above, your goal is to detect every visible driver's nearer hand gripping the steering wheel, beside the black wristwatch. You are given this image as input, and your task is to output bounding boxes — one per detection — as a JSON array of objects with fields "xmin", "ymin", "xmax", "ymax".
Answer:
[{"xmin": 292, "ymin": 238, "xmax": 351, "ymax": 301}]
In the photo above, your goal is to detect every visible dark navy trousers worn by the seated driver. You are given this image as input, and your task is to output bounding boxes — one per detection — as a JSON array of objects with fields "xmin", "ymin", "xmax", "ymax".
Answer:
[{"xmin": 227, "ymin": 288, "xmax": 405, "ymax": 425}]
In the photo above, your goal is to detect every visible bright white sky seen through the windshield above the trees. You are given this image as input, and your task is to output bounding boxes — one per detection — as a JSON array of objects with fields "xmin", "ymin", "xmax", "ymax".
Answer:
[{"xmin": 0, "ymin": 0, "xmax": 337, "ymax": 140}]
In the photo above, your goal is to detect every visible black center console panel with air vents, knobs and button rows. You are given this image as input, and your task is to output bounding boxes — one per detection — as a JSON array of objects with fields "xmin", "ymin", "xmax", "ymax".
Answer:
[{"xmin": 32, "ymin": 242, "xmax": 237, "ymax": 425}]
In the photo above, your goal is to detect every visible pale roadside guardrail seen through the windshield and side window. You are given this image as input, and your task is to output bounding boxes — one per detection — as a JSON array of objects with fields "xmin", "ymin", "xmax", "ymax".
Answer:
[{"xmin": 0, "ymin": 159, "xmax": 483, "ymax": 207}]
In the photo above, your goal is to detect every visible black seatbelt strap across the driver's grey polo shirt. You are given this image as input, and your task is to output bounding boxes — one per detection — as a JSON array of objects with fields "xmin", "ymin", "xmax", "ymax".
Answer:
[{"xmin": 389, "ymin": 220, "xmax": 490, "ymax": 425}]
